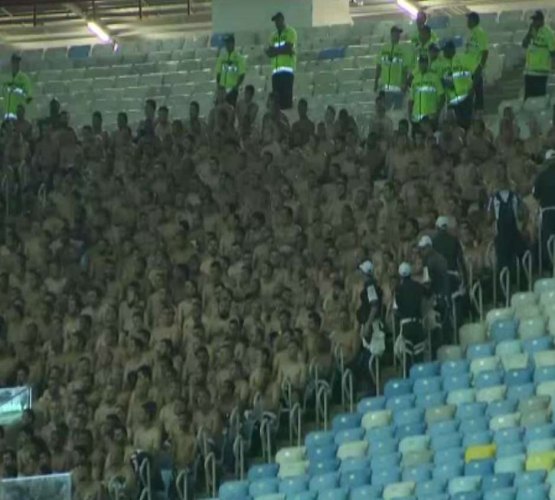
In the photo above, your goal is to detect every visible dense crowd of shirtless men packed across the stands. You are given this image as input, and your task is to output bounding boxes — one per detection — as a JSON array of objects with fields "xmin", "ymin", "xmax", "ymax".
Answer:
[{"xmin": 0, "ymin": 6, "xmax": 555, "ymax": 499}]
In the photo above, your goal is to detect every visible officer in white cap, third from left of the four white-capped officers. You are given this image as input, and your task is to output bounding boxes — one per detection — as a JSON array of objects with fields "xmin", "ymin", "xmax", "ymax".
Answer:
[{"xmin": 418, "ymin": 236, "xmax": 452, "ymax": 354}]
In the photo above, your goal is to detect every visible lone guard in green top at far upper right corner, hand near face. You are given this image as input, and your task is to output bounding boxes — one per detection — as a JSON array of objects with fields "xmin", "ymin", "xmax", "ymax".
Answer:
[{"xmin": 522, "ymin": 10, "xmax": 555, "ymax": 99}]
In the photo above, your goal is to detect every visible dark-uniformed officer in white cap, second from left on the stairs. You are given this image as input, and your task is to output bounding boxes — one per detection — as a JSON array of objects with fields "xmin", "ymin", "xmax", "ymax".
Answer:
[{"xmin": 394, "ymin": 262, "xmax": 428, "ymax": 376}]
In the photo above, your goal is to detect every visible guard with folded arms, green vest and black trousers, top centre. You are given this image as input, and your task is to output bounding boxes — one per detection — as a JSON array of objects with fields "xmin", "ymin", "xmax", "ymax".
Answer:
[{"xmin": 266, "ymin": 12, "xmax": 297, "ymax": 109}]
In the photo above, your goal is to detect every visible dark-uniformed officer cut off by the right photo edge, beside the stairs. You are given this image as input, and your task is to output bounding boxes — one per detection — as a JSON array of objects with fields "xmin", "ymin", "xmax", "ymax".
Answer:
[{"xmin": 534, "ymin": 149, "xmax": 555, "ymax": 265}]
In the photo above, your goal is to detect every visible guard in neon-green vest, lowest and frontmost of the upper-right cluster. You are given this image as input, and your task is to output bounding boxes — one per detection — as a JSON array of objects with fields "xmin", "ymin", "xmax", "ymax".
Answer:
[{"xmin": 409, "ymin": 56, "xmax": 444, "ymax": 133}]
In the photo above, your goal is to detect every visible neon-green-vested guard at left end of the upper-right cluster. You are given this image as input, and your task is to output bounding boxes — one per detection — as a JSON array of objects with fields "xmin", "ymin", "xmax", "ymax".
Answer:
[{"xmin": 374, "ymin": 26, "xmax": 409, "ymax": 109}]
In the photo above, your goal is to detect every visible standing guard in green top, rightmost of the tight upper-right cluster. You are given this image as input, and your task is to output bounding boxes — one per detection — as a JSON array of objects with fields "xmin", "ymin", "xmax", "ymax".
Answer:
[{"xmin": 466, "ymin": 12, "xmax": 489, "ymax": 111}]
